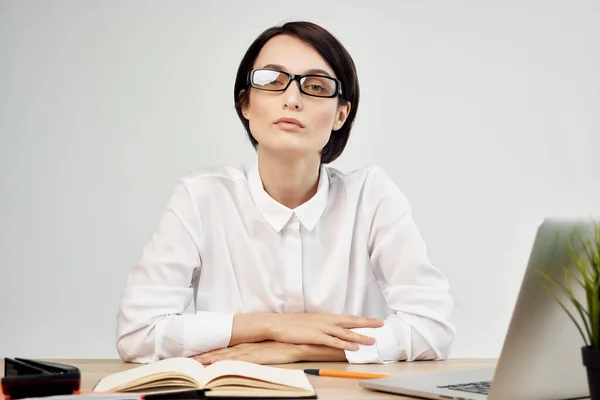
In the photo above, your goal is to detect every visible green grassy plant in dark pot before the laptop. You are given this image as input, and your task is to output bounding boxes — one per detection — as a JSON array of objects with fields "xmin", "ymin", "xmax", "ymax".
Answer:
[{"xmin": 538, "ymin": 222, "xmax": 600, "ymax": 400}]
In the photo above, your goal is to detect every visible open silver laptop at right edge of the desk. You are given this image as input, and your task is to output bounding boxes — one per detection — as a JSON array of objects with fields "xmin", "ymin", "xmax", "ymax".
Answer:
[{"xmin": 359, "ymin": 218, "xmax": 594, "ymax": 400}]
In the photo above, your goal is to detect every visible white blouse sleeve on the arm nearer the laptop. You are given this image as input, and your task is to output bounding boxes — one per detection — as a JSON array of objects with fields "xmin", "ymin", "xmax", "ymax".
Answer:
[{"xmin": 346, "ymin": 168, "xmax": 455, "ymax": 363}]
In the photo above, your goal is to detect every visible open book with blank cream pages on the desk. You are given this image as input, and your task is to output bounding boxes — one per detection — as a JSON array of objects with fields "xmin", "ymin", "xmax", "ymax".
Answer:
[{"xmin": 94, "ymin": 357, "xmax": 317, "ymax": 398}]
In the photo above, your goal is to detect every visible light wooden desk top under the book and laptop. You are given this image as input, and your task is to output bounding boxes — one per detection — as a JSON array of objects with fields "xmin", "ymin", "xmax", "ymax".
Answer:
[{"xmin": 0, "ymin": 359, "xmax": 497, "ymax": 400}]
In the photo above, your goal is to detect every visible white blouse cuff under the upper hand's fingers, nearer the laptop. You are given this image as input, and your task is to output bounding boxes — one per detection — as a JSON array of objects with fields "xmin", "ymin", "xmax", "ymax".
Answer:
[{"xmin": 344, "ymin": 321, "xmax": 403, "ymax": 364}]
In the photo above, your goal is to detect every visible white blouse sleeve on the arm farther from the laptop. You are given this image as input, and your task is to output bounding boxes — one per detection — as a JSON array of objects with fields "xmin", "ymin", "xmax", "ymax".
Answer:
[{"xmin": 116, "ymin": 182, "xmax": 233, "ymax": 363}]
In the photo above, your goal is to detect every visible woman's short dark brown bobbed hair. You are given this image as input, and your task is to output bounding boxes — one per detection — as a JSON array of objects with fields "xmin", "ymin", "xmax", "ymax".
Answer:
[{"xmin": 233, "ymin": 21, "xmax": 360, "ymax": 164}]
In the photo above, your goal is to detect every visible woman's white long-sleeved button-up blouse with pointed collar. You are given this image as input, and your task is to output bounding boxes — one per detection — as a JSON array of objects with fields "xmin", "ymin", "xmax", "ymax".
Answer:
[{"xmin": 117, "ymin": 165, "xmax": 454, "ymax": 363}]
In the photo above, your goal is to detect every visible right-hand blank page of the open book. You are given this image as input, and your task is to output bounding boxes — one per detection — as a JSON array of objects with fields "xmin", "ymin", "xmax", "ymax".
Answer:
[{"xmin": 204, "ymin": 360, "xmax": 314, "ymax": 392}]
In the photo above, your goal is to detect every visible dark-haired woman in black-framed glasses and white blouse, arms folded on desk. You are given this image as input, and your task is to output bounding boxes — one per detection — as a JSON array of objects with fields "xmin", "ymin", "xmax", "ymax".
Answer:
[{"xmin": 117, "ymin": 22, "xmax": 454, "ymax": 364}]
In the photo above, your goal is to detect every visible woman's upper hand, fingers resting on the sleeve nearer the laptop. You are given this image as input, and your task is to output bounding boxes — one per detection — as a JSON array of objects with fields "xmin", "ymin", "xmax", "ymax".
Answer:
[{"xmin": 264, "ymin": 313, "xmax": 383, "ymax": 350}]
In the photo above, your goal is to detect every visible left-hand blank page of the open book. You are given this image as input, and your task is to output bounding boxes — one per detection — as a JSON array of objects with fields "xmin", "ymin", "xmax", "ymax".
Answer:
[{"xmin": 93, "ymin": 357, "xmax": 205, "ymax": 392}]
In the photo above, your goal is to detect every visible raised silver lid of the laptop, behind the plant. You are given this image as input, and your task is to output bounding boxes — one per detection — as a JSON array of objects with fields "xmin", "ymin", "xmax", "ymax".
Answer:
[{"xmin": 489, "ymin": 219, "xmax": 593, "ymax": 399}]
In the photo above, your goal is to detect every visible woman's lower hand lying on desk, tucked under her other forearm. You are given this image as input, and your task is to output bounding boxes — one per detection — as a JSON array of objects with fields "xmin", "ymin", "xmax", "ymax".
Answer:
[{"xmin": 192, "ymin": 341, "xmax": 302, "ymax": 365}]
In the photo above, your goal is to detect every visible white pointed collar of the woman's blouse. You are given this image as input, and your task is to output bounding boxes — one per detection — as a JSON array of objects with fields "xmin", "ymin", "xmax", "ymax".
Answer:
[{"xmin": 248, "ymin": 164, "xmax": 329, "ymax": 232}]
